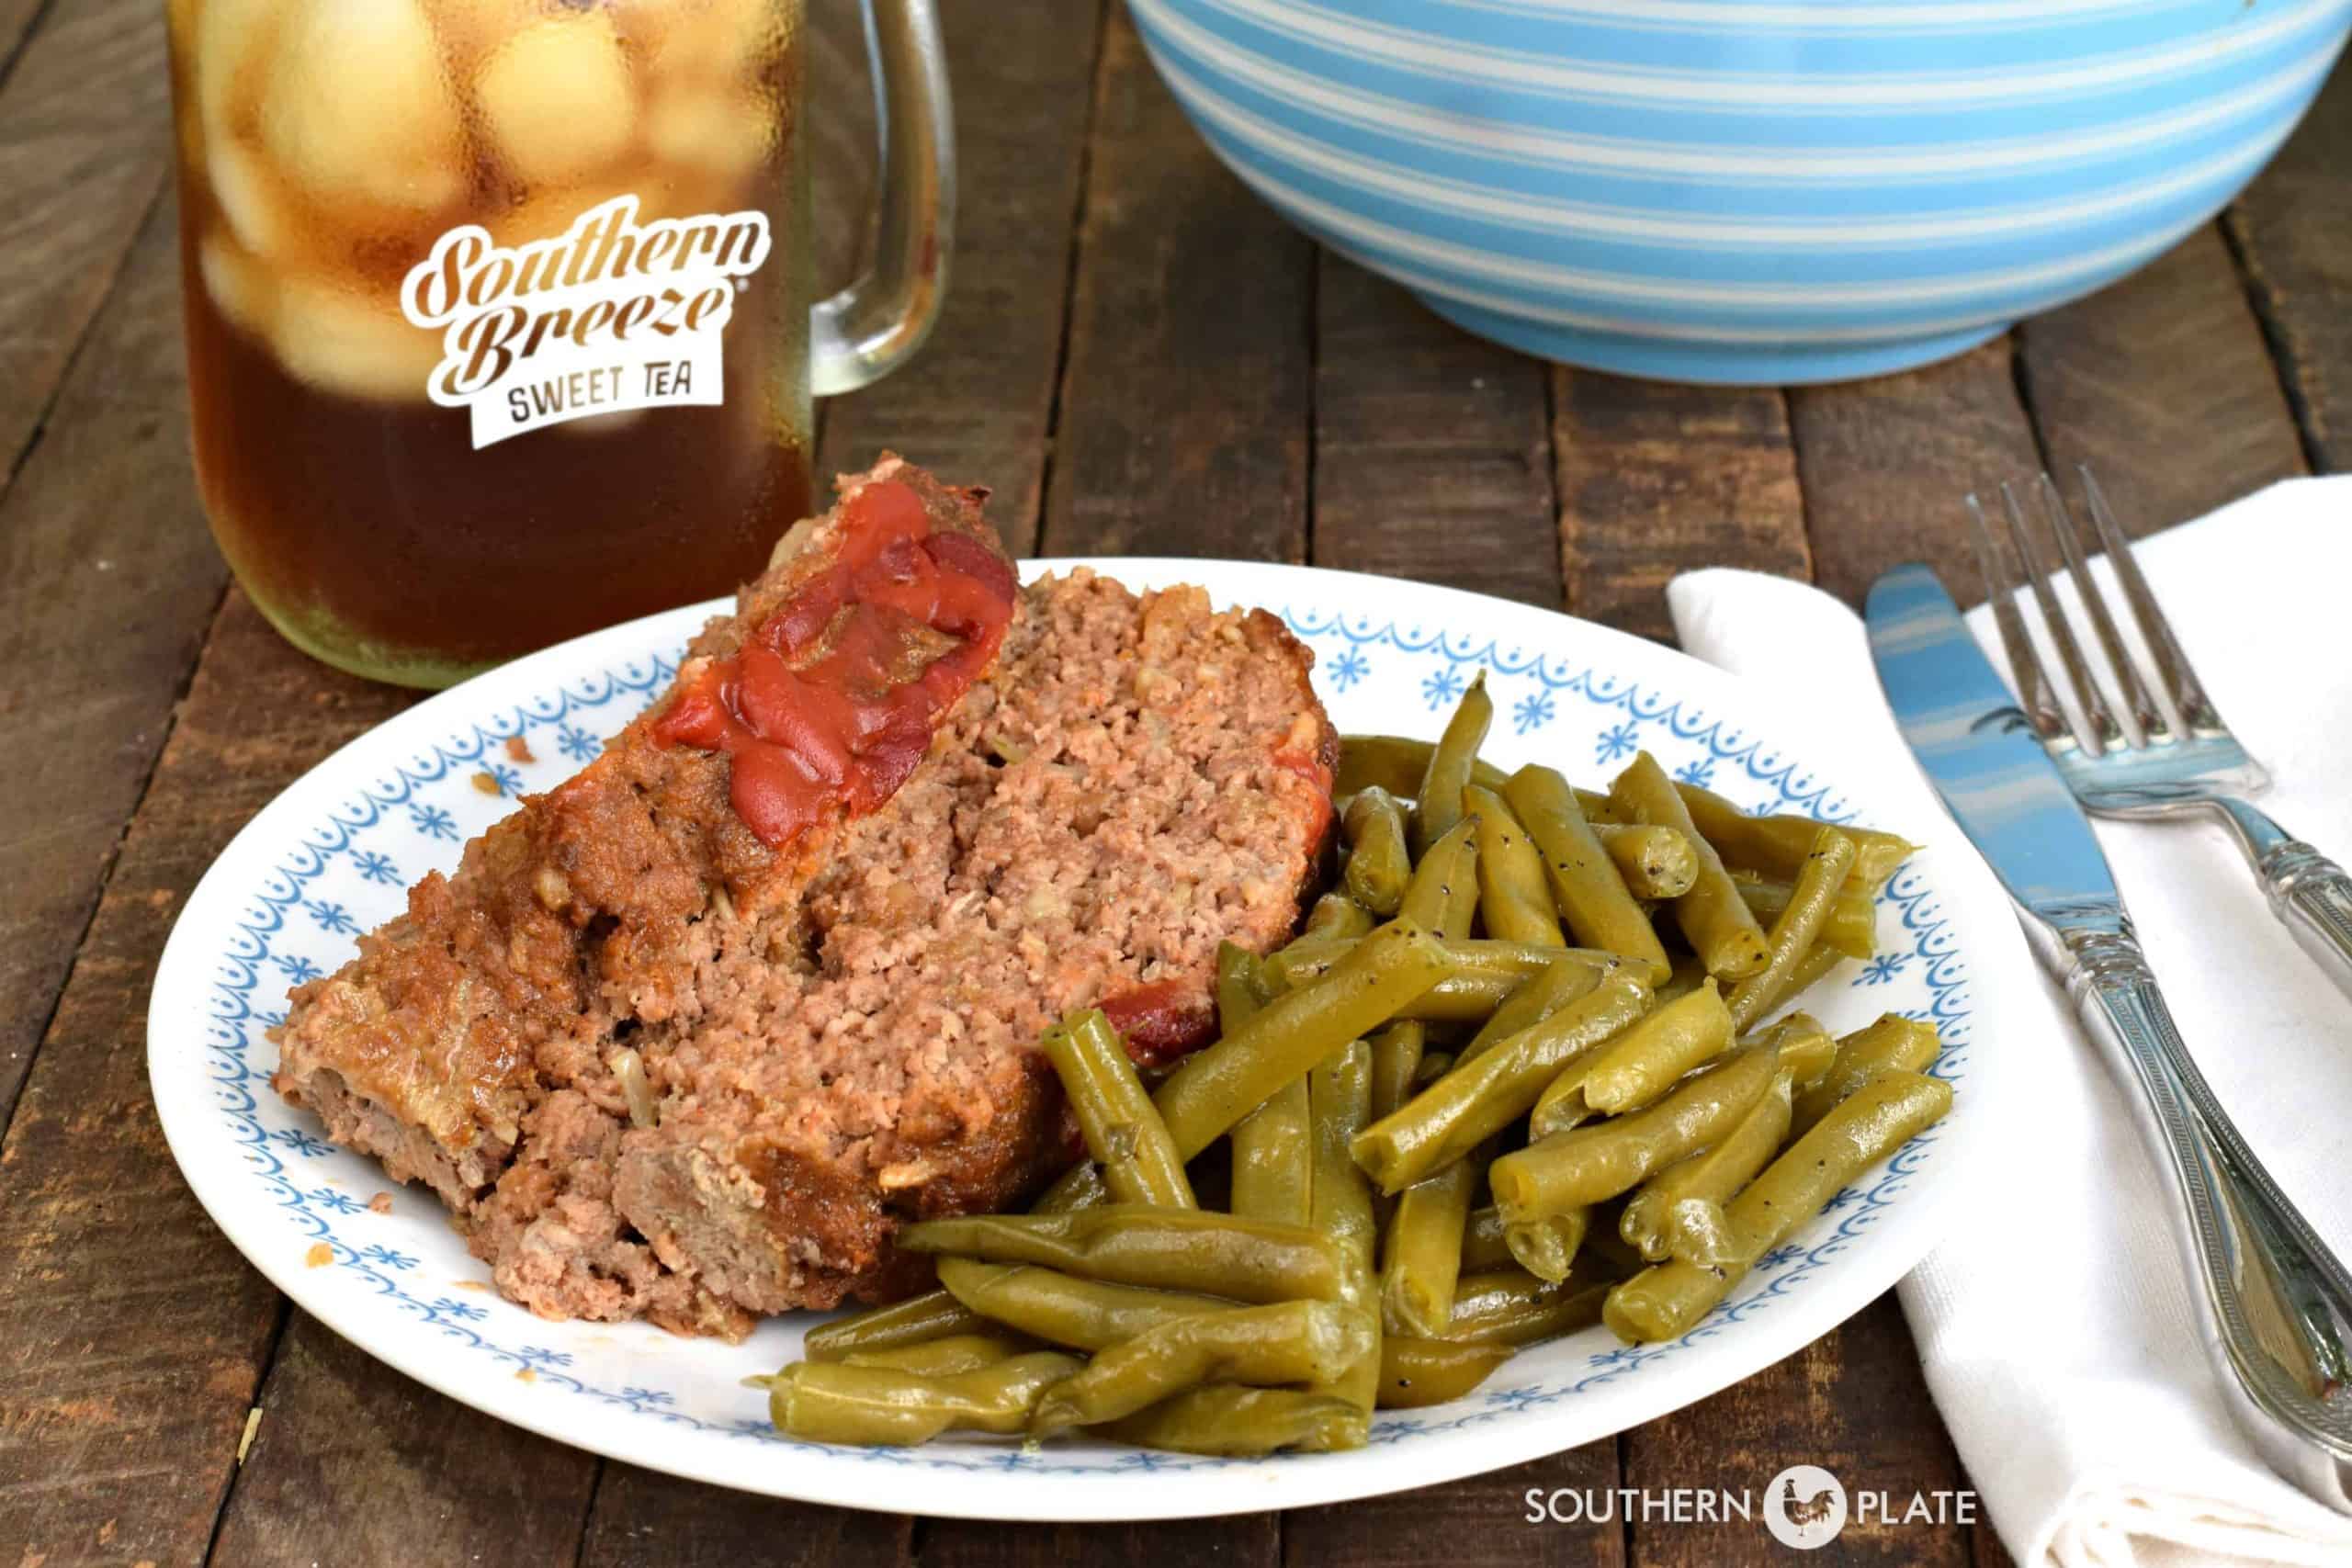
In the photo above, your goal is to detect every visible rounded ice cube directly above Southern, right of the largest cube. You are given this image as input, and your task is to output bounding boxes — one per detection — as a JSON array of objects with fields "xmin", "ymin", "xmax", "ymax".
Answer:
[{"xmin": 473, "ymin": 9, "xmax": 638, "ymax": 184}]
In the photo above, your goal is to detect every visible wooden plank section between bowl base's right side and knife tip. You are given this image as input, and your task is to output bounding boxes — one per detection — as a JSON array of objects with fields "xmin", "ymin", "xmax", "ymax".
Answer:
[{"xmin": 1788, "ymin": 339, "xmax": 2041, "ymax": 604}]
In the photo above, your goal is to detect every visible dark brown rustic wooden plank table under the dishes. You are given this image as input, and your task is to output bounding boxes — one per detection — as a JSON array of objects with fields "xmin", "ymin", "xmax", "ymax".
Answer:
[{"xmin": 0, "ymin": 0, "xmax": 2352, "ymax": 1568}]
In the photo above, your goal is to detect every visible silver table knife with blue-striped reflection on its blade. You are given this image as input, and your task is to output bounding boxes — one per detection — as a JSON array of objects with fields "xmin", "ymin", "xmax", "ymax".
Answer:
[{"xmin": 1863, "ymin": 567, "xmax": 2352, "ymax": 1514}]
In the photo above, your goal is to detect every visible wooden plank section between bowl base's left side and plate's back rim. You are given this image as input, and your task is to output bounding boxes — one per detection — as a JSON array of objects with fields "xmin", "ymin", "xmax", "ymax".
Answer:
[{"xmin": 1312, "ymin": 252, "xmax": 1562, "ymax": 609}]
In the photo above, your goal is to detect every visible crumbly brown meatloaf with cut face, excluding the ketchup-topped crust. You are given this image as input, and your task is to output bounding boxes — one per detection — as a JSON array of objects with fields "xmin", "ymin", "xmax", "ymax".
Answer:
[{"xmin": 277, "ymin": 470, "xmax": 1336, "ymax": 1333}]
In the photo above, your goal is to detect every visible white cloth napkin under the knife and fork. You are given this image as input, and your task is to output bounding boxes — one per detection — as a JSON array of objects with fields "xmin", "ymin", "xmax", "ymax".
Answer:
[{"xmin": 1668, "ymin": 478, "xmax": 2352, "ymax": 1568}]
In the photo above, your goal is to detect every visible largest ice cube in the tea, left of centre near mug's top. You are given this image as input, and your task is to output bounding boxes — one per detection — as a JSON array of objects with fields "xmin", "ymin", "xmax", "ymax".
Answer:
[{"xmin": 261, "ymin": 0, "xmax": 468, "ymax": 216}]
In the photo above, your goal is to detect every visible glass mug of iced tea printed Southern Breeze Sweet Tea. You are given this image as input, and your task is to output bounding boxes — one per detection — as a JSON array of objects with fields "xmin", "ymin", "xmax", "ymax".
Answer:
[{"xmin": 167, "ymin": 0, "xmax": 953, "ymax": 686}]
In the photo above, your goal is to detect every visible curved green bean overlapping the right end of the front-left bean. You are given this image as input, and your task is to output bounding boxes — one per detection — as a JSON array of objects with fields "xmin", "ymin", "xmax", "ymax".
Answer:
[{"xmin": 1030, "ymin": 1303, "xmax": 1376, "ymax": 1437}]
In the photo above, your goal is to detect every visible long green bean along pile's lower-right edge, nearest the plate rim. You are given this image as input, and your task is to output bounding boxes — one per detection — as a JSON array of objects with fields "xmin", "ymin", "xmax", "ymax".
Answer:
[{"xmin": 1604, "ymin": 1072, "xmax": 1952, "ymax": 1345}]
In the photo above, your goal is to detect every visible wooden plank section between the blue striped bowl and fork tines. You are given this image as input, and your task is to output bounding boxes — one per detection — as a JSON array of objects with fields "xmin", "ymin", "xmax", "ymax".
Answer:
[{"xmin": 2018, "ymin": 223, "xmax": 2304, "ymax": 534}]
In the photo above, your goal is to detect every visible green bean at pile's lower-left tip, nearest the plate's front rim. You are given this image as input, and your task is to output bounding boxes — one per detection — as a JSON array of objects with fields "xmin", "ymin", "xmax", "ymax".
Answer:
[{"xmin": 767, "ymin": 1349, "xmax": 1082, "ymax": 1446}]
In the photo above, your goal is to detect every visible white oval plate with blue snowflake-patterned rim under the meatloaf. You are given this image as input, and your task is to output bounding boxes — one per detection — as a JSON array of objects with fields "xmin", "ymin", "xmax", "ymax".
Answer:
[{"xmin": 148, "ymin": 559, "xmax": 2018, "ymax": 1518}]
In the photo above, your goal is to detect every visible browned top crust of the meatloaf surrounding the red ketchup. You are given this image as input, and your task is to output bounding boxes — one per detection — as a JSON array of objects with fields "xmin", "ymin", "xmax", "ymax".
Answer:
[{"xmin": 273, "ymin": 456, "xmax": 1013, "ymax": 1213}]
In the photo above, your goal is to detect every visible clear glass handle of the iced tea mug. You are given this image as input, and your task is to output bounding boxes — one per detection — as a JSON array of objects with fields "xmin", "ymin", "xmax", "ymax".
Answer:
[{"xmin": 809, "ymin": 0, "xmax": 955, "ymax": 398}]
